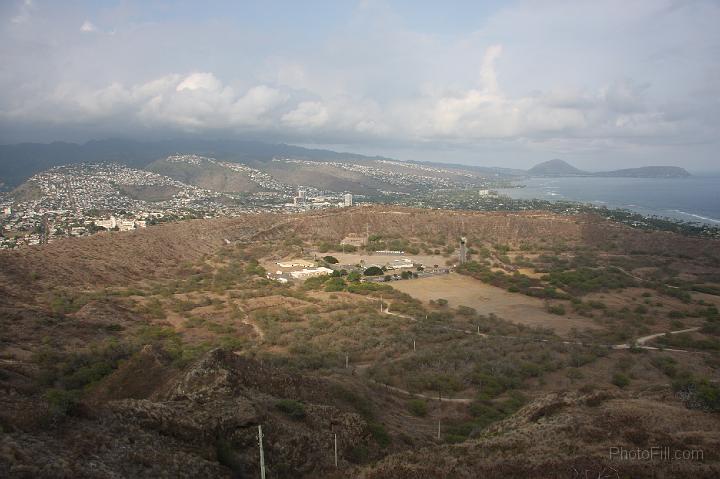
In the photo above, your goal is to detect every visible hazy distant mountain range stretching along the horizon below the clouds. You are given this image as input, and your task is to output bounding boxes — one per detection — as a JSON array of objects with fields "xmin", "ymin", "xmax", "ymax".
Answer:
[{"xmin": 0, "ymin": 139, "xmax": 689, "ymax": 191}]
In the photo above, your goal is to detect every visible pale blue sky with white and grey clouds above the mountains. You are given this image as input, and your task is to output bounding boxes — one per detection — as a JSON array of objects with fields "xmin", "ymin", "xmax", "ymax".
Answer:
[{"xmin": 0, "ymin": 0, "xmax": 720, "ymax": 171}]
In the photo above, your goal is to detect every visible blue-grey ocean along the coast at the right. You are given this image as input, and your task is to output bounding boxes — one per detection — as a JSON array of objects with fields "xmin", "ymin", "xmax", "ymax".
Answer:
[{"xmin": 498, "ymin": 176, "xmax": 720, "ymax": 226}]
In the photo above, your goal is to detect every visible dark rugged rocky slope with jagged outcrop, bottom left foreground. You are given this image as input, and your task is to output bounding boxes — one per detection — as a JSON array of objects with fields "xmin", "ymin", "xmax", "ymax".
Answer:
[{"xmin": 0, "ymin": 348, "xmax": 372, "ymax": 478}]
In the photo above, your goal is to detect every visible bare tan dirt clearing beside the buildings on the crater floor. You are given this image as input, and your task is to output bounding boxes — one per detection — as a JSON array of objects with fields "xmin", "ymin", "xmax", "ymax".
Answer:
[{"xmin": 390, "ymin": 273, "xmax": 598, "ymax": 335}]
